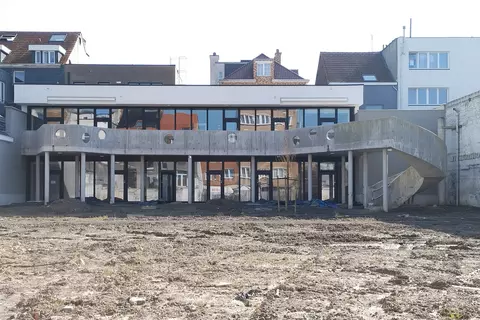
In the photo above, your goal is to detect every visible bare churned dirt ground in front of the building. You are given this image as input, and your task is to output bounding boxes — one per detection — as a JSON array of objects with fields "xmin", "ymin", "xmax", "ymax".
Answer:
[{"xmin": 0, "ymin": 202, "xmax": 480, "ymax": 320}]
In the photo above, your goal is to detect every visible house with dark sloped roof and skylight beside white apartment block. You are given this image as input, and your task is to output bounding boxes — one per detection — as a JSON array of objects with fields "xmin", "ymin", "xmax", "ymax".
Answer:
[{"xmin": 315, "ymin": 52, "xmax": 398, "ymax": 110}]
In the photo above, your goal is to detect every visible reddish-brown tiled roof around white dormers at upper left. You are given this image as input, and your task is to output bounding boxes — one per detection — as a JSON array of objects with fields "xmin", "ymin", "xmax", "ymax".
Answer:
[{"xmin": 0, "ymin": 31, "xmax": 81, "ymax": 64}]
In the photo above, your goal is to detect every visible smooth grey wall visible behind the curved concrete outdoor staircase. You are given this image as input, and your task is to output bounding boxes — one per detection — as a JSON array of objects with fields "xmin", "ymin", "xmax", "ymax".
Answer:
[{"xmin": 355, "ymin": 110, "xmax": 444, "ymax": 205}]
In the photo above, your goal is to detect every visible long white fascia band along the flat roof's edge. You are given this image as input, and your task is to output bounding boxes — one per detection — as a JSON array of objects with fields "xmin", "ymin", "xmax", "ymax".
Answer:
[{"xmin": 15, "ymin": 84, "xmax": 363, "ymax": 107}]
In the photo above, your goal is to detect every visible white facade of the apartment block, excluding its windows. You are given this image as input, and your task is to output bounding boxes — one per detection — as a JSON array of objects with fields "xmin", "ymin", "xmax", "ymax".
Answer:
[{"xmin": 396, "ymin": 38, "xmax": 480, "ymax": 110}]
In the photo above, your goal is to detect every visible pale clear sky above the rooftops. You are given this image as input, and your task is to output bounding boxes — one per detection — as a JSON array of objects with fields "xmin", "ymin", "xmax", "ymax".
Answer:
[{"xmin": 0, "ymin": 0, "xmax": 480, "ymax": 84}]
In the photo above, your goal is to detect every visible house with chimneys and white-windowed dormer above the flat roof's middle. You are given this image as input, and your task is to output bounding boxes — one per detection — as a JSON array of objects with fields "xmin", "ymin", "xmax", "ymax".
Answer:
[{"xmin": 210, "ymin": 49, "xmax": 308, "ymax": 85}]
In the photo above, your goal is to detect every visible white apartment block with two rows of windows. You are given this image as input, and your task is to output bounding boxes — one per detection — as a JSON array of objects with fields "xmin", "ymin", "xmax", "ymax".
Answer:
[{"xmin": 382, "ymin": 37, "xmax": 480, "ymax": 110}]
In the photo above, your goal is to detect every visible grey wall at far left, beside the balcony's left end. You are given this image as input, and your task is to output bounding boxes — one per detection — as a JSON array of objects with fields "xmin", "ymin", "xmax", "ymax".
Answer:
[{"xmin": 0, "ymin": 107, "xmax": 27, "ymax": 205}]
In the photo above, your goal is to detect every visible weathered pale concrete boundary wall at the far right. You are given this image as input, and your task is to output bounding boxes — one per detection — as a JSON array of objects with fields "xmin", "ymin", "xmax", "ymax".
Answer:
[{"xmin": 445, "ymin": 91, "xmax": 480, "ymax": 207}]
